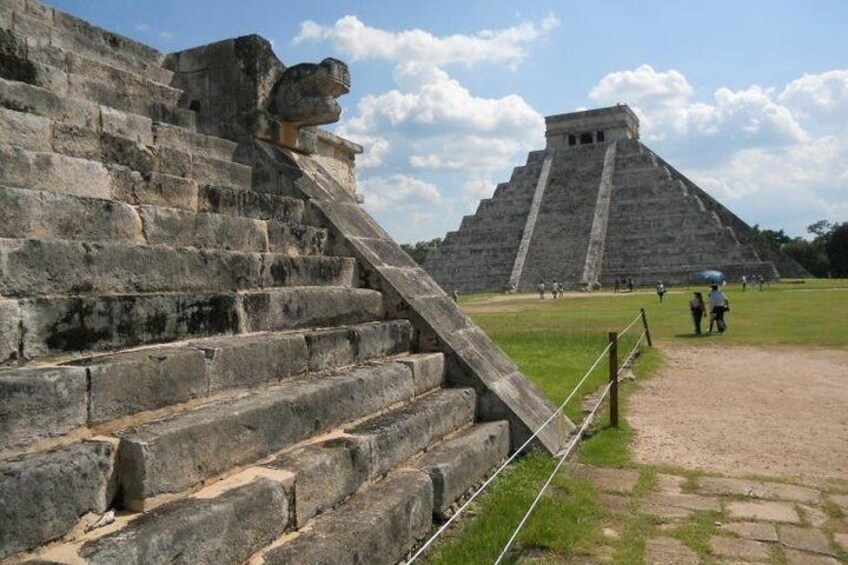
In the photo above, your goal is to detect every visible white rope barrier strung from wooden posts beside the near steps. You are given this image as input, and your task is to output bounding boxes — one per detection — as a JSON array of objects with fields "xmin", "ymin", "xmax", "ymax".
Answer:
[{"xmin": 406, "ymin": 313, "xmax": 645, "ymax": 565}]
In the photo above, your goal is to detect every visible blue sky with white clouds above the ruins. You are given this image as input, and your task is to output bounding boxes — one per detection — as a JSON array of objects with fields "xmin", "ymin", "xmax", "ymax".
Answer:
[{"xmin": 48, "ymin": 0, "xmax": 848, "ymax": 243}]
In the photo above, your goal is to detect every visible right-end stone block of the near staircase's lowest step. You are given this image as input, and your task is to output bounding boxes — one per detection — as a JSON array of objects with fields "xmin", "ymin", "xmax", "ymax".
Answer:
[{"xmin": 415, "ymin": 422, "xmax": 509, "ymax": 516}]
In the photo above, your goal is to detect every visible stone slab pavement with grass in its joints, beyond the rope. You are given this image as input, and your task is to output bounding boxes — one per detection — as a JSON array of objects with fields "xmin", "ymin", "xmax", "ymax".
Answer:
[{"xmin": 571, "ymin": 465, "xmax": 848, "ymax": 565}]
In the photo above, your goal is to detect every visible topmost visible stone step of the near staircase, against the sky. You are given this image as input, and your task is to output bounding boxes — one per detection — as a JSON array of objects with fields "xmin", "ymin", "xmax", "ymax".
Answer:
[{"xmin": 6, "ymin": 0, "xmax": 173, "ymax": 84}]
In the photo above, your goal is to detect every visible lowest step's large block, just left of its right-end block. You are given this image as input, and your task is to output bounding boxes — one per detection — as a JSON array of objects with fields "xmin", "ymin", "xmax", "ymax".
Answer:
[{"xmin": 261, "ymin": 469, "xmax": 433, "ymax": 565}]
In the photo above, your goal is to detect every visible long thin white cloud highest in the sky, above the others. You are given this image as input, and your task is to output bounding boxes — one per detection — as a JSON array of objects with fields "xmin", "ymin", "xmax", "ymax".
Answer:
[{"xmin": 294, "ymin": 14, "xmax": 559, "ymax": 66}]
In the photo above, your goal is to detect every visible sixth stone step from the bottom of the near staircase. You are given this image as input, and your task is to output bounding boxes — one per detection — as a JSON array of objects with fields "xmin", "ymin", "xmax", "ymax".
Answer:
[{"xmin": 0, "ymin": 239, "xmax": 356, "ymax": 298}]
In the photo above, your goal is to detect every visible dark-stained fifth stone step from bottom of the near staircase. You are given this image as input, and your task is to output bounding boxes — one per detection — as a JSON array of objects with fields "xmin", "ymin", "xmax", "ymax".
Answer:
[{"xmin": 13, "ymin": 287, "xmax": 384, "ymax": 359}]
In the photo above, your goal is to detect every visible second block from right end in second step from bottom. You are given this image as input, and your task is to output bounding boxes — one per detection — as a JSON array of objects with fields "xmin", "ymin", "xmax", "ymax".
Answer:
[{"xmin": 267, "ymin": 438, "xmax": 369, "ymax": 528}]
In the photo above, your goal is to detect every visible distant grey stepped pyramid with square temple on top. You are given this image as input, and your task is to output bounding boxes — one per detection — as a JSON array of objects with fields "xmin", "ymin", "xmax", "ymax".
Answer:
[{"xmin": 425, "ymin": 105, "xmax": 809, "ymax": 292}]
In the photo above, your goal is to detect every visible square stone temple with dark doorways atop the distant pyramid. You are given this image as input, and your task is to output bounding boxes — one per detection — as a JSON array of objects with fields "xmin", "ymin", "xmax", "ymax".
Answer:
[{"xmin": 545, "ymin": 104, "xmax": 639, "ymax": 147}]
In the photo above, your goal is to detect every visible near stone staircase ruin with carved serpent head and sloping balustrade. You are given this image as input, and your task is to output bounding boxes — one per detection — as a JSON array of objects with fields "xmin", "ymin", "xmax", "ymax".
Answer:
[{"xmin": 0, "ymin": 0, "xmax": 571, "ymax": 564}]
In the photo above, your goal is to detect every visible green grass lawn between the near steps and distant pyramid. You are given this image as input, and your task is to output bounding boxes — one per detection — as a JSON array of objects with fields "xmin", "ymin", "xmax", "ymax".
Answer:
[{"xmin": 426, "ymin": 280, "xmax": 848, "ymax": 564}]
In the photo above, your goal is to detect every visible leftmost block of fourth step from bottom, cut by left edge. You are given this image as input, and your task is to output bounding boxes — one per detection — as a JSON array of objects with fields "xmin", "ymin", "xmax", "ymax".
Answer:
[{"xmin": 0, "ymin": 367, "xmax": 88, "ymax": 450}]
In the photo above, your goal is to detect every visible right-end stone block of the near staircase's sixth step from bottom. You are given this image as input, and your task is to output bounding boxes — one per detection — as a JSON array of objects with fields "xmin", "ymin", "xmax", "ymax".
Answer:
[{"xmin": 262, "ymin": 253, "xmax": 356, "ymax": 287}]
